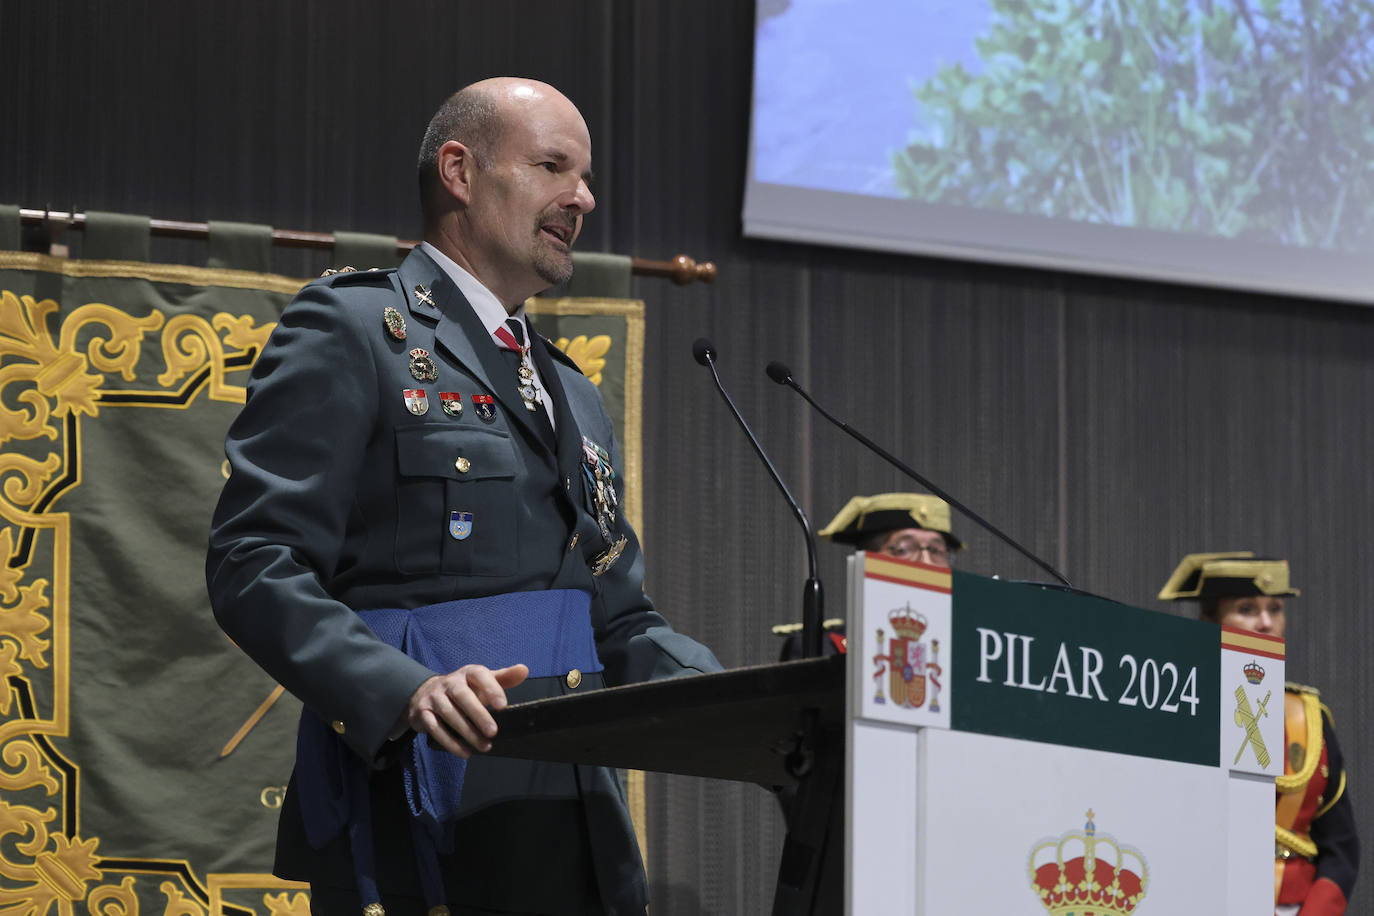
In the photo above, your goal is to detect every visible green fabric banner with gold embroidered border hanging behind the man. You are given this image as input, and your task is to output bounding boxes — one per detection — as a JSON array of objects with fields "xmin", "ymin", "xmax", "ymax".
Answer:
[{"xmin": 0, "ymin": 251, "xmax": 643, "ymax": 916}]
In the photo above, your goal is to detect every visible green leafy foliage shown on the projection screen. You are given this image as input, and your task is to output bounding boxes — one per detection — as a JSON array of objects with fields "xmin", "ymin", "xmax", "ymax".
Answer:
[{"xmin": 894, "ymin": 0, "xmax": 1374, "ymax": 251}]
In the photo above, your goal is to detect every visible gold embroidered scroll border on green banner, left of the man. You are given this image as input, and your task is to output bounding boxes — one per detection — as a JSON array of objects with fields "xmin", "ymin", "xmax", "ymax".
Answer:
[{"xmin": 0, "ymin": 290, "xmax": 276, "ymax": 916}]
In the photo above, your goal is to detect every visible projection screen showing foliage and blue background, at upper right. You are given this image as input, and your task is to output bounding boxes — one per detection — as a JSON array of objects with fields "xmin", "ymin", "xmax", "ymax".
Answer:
[{"xmin": 743, "ymin": 0, "xmax": 1374, "ymax": 304}]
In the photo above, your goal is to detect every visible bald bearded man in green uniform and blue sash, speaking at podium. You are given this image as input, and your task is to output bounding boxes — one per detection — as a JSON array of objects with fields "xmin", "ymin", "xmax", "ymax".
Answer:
[{"xmin": 206, "ymin": 78, "xmax": 720, "ymax": 916}]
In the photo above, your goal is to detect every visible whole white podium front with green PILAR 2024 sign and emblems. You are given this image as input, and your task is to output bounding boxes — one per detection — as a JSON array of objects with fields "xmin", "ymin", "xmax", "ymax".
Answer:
[{"xmin": 845, "ymin": 553, "xmax": 1285, "ymax": 916}]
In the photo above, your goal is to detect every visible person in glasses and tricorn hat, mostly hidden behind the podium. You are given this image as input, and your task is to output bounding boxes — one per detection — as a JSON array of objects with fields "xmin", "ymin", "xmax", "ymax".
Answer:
[{"xmin": 774, "ymin": 493, "xmax": 963, "ymax": 662}]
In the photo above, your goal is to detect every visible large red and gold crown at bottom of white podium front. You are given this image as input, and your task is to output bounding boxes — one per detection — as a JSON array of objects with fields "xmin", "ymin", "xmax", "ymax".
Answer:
[{"xmin": 1029, "ymin": 809, "xmax": 1149, "ymax": 916}]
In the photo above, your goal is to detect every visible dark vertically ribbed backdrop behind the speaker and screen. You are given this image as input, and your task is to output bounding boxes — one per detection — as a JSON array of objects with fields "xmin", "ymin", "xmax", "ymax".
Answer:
[{"xmin": 0, "ymin": 0, "xmax": 1374, "ymax": 916}]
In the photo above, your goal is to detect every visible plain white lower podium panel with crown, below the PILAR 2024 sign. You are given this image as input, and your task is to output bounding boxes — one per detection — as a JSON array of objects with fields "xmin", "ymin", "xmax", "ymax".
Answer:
[{"xmin": 912, "ymin": 729, "xmax": 1225, "ymax": 916}]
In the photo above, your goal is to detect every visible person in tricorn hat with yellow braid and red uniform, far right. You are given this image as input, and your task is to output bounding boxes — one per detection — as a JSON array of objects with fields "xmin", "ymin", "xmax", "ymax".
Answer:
[{"xmin": 1160, "ymin": 552, "xmax": 1360, "ymax": 916}]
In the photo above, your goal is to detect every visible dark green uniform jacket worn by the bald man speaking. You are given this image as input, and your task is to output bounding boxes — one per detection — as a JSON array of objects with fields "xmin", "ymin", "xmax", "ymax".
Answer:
[{"xmin": 206, "ymin": 249, "xmax": 720, "ymax": 913}]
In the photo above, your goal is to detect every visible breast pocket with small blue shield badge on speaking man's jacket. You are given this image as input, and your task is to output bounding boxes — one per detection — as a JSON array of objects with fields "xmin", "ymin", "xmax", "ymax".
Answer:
[{"xmin": 396, "ymin": 426, "xmax": 519, "ymax": 575}]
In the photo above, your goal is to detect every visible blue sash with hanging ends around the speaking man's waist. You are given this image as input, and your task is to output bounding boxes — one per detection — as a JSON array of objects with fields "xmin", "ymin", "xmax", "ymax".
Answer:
[{"xmin": 295, "ymin": 589, "xmax": 602, "ymax": 906}]
